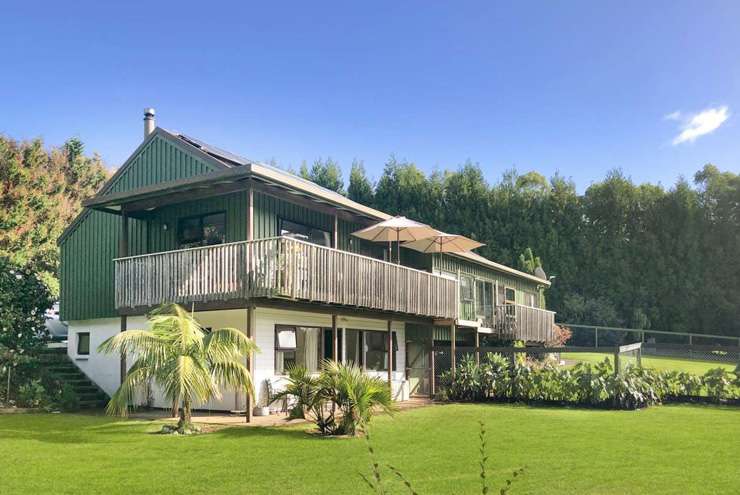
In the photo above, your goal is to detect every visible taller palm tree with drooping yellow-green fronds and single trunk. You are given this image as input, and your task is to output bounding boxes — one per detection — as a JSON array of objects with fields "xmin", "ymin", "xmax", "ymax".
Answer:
[{"xmin": 98, "ymin": 304, "xmax": 259, "ymax": 431}]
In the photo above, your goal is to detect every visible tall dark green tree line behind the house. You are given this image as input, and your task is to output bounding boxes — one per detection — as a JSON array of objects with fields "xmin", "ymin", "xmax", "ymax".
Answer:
[{"xmin": 299, "ymin": 157, "xmax": 740, "ymax": 335}]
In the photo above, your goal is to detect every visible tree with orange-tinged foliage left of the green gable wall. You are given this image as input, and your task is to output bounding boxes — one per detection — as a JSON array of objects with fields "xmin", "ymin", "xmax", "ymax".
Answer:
[{"xmin": 0, "ymin": 136, "xmax": 107, "ymax": 292}]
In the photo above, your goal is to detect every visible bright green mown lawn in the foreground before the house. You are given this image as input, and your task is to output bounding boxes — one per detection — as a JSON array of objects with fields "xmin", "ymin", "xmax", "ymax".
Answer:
[{"xmin": 0, "ymin": 405, "xmax": 740, "ymax": 494}]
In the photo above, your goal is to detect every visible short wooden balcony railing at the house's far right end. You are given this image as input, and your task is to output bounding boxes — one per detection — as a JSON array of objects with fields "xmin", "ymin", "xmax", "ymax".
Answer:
[{"xmin": 493, "ymin": 304, "xmax": 555, "ymax": 342}]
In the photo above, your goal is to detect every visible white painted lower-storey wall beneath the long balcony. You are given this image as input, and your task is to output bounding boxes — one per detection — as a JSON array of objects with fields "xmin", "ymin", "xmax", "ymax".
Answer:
[{"xmin": 67, "ymin": 308, "xmax": 409, "ymax": 411}]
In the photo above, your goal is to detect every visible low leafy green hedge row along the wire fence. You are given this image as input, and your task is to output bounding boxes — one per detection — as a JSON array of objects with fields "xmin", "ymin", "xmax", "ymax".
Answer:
[{"xmin": 440, "ymin": 353, "xmax": 740, "ymax": 409}]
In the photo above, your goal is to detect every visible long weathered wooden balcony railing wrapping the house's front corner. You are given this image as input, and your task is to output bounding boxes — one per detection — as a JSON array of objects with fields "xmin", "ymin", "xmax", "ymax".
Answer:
[{"xmin": 115, "ymin": 237, "xmax": 458, "ymax": 318}]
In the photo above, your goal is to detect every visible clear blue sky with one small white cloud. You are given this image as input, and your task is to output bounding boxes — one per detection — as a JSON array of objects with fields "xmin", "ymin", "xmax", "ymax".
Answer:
[{"xmin": 0, "ymin": 1, "xmax": 740, "ymax": 190}]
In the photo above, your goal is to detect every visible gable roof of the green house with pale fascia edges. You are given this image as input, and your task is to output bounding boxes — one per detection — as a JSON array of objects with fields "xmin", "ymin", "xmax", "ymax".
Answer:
[{"xmin": 65, "ymin": 127, "xmax": 550, "ymax": 286}]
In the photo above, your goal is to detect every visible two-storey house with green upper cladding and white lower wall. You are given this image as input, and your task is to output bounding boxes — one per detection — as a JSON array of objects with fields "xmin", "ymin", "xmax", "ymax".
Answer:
[{"xmin": 59, "ymin": 112, "xmax": 553, "ymax": 410}]
